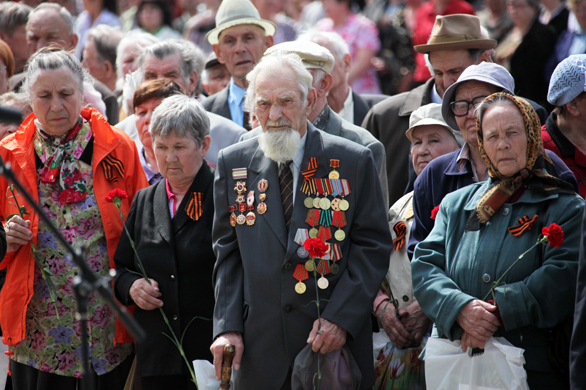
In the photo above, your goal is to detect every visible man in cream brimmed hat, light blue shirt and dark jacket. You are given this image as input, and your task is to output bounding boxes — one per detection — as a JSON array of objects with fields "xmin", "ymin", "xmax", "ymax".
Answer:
[{"xmin": 203, "ymin": 0, "xmax": 276, "ymax": 130}]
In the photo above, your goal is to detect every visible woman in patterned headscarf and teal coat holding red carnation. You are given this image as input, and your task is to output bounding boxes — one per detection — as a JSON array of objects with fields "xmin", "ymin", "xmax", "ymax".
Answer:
[{"xmin": 412, "ymin": 93, "xmax": 584, "ymax": 390}]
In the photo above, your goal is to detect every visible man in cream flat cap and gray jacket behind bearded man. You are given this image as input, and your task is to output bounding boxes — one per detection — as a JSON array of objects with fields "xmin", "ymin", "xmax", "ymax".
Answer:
[{"xmin": 240, "ymin": 40, "xmax": 389, "ymax": 209}]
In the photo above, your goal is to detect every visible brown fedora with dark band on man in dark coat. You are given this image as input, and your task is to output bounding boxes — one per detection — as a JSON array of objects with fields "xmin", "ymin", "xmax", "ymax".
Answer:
[{"xmin": 413, "ymin": 14, "xmax": 496, "ymax": 54}]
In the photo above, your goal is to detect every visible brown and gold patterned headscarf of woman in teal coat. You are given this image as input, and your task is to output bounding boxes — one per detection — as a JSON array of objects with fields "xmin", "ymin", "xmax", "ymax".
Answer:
[{"xmin": 467, "ymin": 92, "xmax": 574, "ymax": 230}]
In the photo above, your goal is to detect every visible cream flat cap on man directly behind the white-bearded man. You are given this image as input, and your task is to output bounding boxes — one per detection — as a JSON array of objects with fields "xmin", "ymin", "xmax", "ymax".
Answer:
[{"xmin": 264, "ymin": 41, "xmax": 336, "ymax": 73}]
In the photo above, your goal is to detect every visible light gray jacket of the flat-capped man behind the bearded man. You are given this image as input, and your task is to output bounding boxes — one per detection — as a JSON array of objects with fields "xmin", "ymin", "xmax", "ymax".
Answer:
[{"xmin": 240, "ymin": 106, "xmax": 389, "ymax": 210}]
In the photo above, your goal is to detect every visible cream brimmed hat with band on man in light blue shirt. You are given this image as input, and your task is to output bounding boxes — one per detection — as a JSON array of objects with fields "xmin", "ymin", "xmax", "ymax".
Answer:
[{"xmin": 206, "ymin": 0, "xmax": 277, "ymax": 45}]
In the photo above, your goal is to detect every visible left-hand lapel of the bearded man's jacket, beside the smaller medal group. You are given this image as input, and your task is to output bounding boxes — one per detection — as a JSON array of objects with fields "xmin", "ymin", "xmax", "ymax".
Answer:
[{"xmin": 247, "ymin": 146, "xmax": 287, "ymax": 248}]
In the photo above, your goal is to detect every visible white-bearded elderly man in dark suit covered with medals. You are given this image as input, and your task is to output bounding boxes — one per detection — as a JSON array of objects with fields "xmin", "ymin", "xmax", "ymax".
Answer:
[{"xmin": 211, "ymin": 53, "xmax": 392, "ymax": 390}]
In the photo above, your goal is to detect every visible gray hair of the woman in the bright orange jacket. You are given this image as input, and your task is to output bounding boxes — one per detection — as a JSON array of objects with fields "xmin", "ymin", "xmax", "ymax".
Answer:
[{"xmin": 22, "ymin": 47, "xmax": 93, "ymax": 99}]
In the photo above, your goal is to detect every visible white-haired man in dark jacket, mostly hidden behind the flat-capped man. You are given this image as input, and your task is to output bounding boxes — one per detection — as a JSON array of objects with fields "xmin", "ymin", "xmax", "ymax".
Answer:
[{"xmin": 299, "ymin": 30, "xmax": 388, "ymax": 126}]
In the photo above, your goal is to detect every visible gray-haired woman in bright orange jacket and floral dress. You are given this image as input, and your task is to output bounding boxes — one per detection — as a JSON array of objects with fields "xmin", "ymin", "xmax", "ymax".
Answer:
[{"xmin": 0, "ymin": 49, "xmax": 148, "ymax": 390}]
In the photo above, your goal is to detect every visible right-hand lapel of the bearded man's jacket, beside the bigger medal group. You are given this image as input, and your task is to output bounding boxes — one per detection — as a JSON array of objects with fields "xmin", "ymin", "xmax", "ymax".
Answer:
[{"xmin": 285, "ymin": 122, "xmax": 329, "ymax": 261}]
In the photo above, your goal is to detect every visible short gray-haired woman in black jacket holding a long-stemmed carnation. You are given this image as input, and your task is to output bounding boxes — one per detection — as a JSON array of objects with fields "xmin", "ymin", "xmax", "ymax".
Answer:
[{"xmin": 114, "ymin": 95, "xmax": 216, "ymax": 390}]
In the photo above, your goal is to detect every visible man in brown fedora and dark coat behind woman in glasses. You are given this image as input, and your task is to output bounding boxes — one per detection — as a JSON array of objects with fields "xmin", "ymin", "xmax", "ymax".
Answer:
[{"xmin": 362, "ymin": 15, "xmax": 496, "ymax": 204}]
